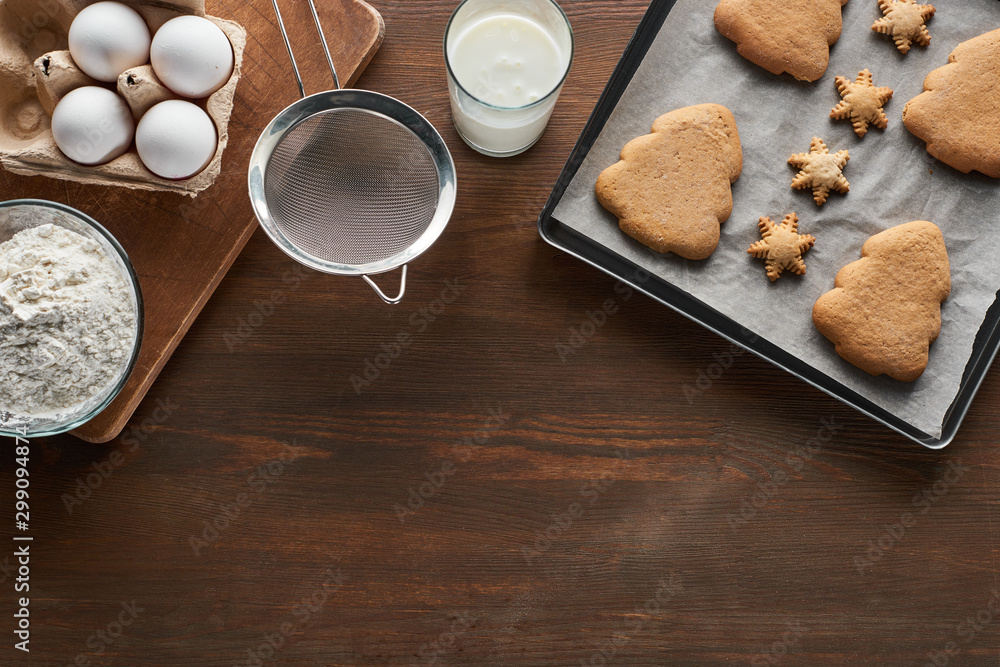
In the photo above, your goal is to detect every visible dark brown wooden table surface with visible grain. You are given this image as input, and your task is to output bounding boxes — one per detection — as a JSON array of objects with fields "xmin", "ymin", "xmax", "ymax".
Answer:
[{"xmin": 0, "ymin": 0, "xmax": 1000, "ymax": 667}]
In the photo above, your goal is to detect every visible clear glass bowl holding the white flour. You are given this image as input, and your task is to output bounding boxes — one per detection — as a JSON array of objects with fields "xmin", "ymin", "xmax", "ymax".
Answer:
[{"xmin": 0, "ymin": 199, "xmax": 143, "ymax": 438}]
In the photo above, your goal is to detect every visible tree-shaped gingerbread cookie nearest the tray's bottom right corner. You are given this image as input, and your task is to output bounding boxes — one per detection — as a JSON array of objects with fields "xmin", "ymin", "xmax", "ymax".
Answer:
[{"xmin": 813, "ymin": 221, "xmax": 951, "ymax": 382}]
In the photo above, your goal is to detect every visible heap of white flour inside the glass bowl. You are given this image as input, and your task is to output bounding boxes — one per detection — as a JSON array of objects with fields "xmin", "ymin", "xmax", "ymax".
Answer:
[{"xmin": 0, "ymin": 225, "xmax": 136, "ymax": 417}]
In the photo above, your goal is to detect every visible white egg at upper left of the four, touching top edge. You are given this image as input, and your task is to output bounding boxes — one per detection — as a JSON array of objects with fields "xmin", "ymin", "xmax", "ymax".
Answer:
[{"xmin": 69, "ymin": 2, "xmax": 150, "ymax": 82}]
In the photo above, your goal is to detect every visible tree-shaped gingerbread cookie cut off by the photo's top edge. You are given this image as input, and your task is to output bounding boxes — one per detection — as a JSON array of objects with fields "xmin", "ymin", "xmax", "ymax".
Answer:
[{"xmin": 715, "ymin": 0, "xmax": 847, "ymax": 81}]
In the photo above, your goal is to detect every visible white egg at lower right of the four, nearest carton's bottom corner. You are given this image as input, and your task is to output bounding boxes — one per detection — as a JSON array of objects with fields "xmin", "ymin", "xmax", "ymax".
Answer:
[{"xmin": 135, "ymin": 100, "xmax": 219, "ymax": 180}]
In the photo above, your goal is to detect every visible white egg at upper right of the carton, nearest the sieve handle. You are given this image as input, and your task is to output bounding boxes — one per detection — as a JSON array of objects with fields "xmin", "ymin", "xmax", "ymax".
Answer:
[{"xmin": 149, "ymin": 16, "xmax": 233, "ymax": 98}]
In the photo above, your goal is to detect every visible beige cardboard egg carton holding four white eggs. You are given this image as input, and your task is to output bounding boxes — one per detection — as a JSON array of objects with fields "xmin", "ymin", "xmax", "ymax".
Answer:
[{"xmin": 0, "ymin": 0, "xmax": 247, "ymax": 197}]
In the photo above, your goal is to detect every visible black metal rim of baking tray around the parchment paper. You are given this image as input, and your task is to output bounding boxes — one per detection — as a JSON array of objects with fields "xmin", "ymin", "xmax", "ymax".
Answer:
[{"xmin": 538, "ymin": 0, "xmax": 1000, "ymax": 449}]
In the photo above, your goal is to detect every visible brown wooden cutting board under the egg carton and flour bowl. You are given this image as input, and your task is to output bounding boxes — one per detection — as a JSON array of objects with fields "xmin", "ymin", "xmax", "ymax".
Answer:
[{"xmin": 0, "ymin": 0, "xmax": 385, "ymax": 442}]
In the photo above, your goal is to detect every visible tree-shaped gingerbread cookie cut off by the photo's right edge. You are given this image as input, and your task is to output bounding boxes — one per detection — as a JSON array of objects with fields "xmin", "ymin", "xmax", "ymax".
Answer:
[{"xmin": 903, "ymin": 30, "xmax": 1000, "ymax": 178}]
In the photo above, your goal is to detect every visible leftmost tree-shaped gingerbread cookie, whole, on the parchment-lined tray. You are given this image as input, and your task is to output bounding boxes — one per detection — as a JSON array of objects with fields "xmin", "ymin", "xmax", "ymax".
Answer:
[{"xmin": 595, "ymin": 104, "xmax": 743, "ymax": 259}]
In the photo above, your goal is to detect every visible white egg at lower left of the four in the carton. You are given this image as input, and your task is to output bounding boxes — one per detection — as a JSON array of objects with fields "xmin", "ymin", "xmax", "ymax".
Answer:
[{"xmin": 52, "ymin": 86, "xmax": 135, "ymax": 166}]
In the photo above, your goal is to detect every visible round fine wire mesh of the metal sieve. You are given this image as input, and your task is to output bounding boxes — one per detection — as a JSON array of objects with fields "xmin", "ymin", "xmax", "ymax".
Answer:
[{"xmin": 264, "ymin": 108, "xmax": 440, "ymax": 266}]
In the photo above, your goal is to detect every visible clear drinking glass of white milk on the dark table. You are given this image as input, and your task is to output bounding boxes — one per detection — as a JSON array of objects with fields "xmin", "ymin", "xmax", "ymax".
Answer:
[{"xmin": 444, "ymin": 0, "xmax": 573, "ymax": 157}]
